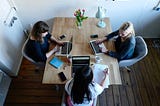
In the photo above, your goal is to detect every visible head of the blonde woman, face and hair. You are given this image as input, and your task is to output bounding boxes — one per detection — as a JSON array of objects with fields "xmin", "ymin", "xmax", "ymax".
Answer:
[{"xmin": 119, "ymin": 22, "xmax": 134, "ymax": 38}]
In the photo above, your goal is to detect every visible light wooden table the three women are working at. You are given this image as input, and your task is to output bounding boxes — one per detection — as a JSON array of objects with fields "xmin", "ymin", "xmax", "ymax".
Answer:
[{"xmin": 42, "ymin": 17, "xmax": 121, "ymax": 85}]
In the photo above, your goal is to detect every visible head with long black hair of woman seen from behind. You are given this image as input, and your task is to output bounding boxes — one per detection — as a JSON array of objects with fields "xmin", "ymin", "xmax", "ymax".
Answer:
[{"xmin": 71, "ymin": 66, "xmax": 93, "ymax": 104}]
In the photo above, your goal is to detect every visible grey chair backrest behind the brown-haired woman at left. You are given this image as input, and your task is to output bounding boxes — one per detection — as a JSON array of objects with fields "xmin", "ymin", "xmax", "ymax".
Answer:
[{"xmin": 22, "ymin": 39, "xmax": 45, "ymax": 67}]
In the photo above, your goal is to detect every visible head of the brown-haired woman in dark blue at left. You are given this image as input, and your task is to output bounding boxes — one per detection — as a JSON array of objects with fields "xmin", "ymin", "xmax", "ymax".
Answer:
[{"xmin": 31, "ymin": 21, "xmax": 49, "ymax": 42}]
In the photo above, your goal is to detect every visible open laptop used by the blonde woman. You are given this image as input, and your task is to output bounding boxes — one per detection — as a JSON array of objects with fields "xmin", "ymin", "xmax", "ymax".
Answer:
[{"xmin": 89, "ymin": 40, "xmax": 107, "ymax": 55}]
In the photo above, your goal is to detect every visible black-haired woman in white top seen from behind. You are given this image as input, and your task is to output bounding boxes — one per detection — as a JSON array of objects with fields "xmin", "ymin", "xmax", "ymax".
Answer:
[{"xmin": 65, "ymin": 67, "xmax": 108, "ymax": 106}]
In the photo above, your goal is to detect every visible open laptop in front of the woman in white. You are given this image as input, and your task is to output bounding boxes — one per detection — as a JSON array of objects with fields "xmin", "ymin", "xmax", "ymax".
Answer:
[{"xmin": 71, "ymin": 56, "xmax": 90, "ymax": 77}]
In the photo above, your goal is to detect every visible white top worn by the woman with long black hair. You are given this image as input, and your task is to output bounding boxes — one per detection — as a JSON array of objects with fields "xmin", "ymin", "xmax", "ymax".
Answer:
[{"xmin": 65, "ymin": 79, "xmax": 104, "ymax": 106}]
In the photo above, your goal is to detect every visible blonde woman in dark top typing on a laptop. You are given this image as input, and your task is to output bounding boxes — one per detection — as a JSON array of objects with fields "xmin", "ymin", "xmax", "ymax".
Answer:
[{"xmin": 97, "ymin": 22, "xmax": 136, "ymax": 61}]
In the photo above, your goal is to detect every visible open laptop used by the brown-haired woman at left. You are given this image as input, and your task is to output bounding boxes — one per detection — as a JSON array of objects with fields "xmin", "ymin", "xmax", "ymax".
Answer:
[{"xmin": 55, "ymin": 37, "xmax": 73, "ymax": 56}]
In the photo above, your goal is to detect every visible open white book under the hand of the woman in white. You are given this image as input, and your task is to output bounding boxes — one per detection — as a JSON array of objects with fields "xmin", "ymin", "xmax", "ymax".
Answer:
[{"xmin": 92, "ymin": 64, "xmax": 110, "ymax": 88}]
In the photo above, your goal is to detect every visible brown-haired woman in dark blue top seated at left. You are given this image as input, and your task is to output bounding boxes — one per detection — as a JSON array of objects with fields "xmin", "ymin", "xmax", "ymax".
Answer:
[{"xmin": 26, "ymin": 21, "xmax": 63, "ymax": 63}]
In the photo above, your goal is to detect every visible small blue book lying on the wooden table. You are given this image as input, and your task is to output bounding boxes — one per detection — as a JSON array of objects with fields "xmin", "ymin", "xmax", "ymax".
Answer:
[{"xmin": 49, "ymin": 56, "xmax": 64, "ymax": 69}]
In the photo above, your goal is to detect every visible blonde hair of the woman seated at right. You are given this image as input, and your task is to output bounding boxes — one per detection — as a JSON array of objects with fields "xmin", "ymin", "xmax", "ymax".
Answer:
[{"xmin": 119, "ymin": 21, "xmax": 135, "ymax": 36}]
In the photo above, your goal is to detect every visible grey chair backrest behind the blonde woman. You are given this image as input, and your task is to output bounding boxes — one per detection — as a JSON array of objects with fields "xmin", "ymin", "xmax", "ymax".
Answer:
[{"xmin": 119, "ymin": 36, "xmax": 148, "ymax": 67}]
